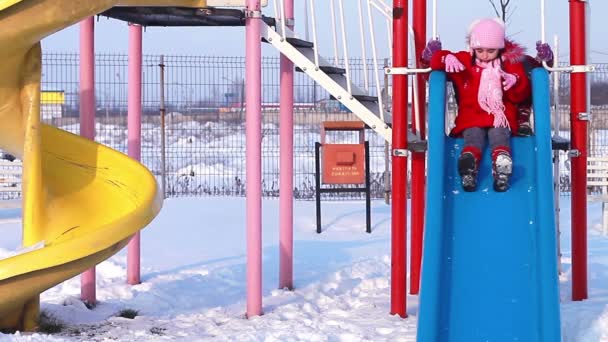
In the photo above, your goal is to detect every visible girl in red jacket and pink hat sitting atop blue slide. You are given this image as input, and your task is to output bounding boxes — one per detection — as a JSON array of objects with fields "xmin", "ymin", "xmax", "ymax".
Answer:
[{"xmin": 430, "ymin": 18, "xmax": 530, "ymax": 192}]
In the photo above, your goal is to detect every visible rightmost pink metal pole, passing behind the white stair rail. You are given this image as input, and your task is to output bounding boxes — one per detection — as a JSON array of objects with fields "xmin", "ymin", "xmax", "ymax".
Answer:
[{"xmin": 279, "ymin": 0, "xmax": 293, "ymax": 290}]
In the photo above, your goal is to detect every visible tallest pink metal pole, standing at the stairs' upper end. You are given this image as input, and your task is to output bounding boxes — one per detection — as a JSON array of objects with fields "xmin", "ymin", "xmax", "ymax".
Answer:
[{"xmin": 245, "ymin": 0, "xmax": 262, "ymax": 317}]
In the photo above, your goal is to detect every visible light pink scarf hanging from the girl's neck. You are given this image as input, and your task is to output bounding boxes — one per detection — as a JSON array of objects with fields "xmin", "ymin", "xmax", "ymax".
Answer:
[{"xmin": 476, "ymin": 58, "xmax": 510, "ymax": 128}]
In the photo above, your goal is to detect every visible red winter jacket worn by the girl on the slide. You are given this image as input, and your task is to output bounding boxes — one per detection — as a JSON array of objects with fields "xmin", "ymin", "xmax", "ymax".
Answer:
[{"xmin": 431, "ymin": 50, "xmax": 531, "ymax": 136}]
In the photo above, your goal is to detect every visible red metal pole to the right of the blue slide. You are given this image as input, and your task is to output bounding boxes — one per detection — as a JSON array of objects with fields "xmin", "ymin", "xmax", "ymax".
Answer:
[{"xmin": 570, "ymin": 0, "xmax": 588, "ymax": 300}]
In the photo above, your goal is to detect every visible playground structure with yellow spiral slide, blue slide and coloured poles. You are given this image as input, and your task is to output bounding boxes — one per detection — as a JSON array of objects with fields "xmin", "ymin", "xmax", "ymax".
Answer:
[{"xmin": 0, "ymin": 0, "xmax": 588, "ymax": 341}]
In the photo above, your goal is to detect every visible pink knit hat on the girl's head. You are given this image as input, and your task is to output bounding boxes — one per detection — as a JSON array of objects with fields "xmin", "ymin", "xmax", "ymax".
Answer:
[{"xmin": 467, "ymin": 18, "xmax": 505, "ymax": 49}]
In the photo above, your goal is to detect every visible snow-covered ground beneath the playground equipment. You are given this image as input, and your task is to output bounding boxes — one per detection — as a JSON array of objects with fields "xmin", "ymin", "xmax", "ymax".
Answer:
[{"xmin": 0, "ymin": 198, "xmax": 608, "ymax": 341}]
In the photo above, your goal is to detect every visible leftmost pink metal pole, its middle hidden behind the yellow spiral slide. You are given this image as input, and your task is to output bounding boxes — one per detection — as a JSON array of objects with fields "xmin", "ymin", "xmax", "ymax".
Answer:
[{"xmin": 79, "ymin": 17, "xmax": 97, "ymax": 304}]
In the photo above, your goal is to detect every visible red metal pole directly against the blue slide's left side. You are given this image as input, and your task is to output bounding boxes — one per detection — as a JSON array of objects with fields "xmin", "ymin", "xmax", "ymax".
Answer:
[{"xmin": 410, "ymin": 0, "xmax": 426, "ymax": 294}]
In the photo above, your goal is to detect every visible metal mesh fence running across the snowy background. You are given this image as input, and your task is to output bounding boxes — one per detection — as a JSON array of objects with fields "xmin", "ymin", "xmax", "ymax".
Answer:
[{"xmin": 0, "ymin": 53, "xmax": 608, "ymax": 199}]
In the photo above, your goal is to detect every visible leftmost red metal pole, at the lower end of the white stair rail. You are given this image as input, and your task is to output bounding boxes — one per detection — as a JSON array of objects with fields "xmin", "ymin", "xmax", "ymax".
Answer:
[{"xmin": 391, "ymin": 0, "xmax": 408, "ymax": 317}]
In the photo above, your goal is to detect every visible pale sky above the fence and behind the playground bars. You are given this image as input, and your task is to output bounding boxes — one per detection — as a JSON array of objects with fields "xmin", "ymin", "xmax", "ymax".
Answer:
[{"xmin": 43, "ymin": 0, "xmax": 608, "ymax": 62}]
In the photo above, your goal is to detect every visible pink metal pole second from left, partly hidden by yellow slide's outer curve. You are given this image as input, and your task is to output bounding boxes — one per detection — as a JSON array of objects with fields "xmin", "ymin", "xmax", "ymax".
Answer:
[{"xmin": 127, "ymin": 25, "xmax": 142, "ymax": 285}]
